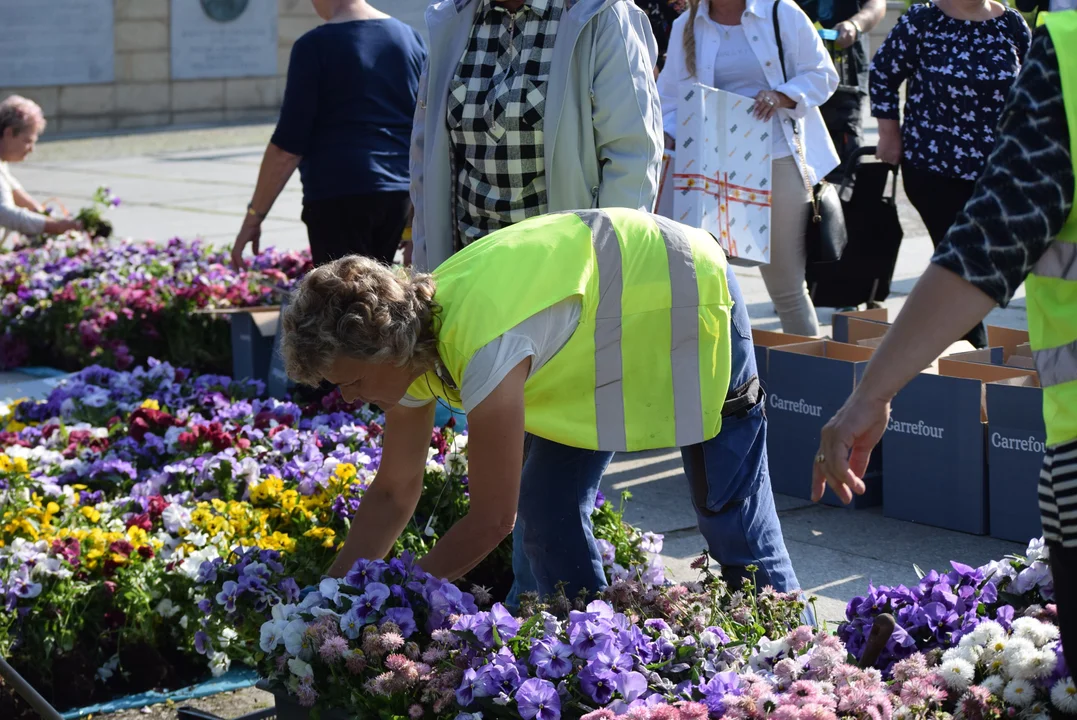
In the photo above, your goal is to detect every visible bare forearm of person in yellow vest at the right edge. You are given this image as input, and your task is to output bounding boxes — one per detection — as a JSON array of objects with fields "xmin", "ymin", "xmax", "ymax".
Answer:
[{"xmin": 856, "ymin": 265, "xmax": 995, "ymax": 403}]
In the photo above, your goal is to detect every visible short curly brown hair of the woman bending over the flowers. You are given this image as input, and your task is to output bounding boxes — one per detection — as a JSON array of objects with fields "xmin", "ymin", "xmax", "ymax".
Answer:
[{"xmin": 280, "ymin": 255, "xmax": 438, "ymax": 386}]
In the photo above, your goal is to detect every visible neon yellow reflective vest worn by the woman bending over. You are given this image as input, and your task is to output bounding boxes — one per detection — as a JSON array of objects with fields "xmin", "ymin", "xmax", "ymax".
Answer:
[{"xmin": 408, "ymin": 209, "xmax": 732, "ymax": 451}]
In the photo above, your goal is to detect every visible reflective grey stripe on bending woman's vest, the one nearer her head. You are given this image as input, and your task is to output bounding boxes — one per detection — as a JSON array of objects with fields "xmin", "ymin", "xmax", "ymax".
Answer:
[{"xmin": 576, "ymin": 210, "xmax": 628, "ymax": 450}]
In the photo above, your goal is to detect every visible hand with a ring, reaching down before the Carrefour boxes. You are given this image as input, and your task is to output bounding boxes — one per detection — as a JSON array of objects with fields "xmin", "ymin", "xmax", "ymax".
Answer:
[{"xmin": 811, "ymin": 392, "xmax": 890, "ymax": 505}]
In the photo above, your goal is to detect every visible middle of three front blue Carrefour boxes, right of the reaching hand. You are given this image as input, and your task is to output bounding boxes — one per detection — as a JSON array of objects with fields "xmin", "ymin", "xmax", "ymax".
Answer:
[{"xmin": 883, "ymin": 357, "xmax": 1029, "ymax": 535}]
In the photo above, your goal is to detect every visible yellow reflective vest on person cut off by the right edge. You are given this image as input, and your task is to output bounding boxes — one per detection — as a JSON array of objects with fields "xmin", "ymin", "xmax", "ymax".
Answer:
[{"xmin": 1025, "ymin": 11, "xmax": 1077, "ymax": 447}]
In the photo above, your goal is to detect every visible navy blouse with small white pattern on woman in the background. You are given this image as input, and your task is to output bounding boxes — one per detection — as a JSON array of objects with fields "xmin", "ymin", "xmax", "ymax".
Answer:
[{"xmin": 870, "ymin": 4, "xmax": 1032, "ymax": 180}]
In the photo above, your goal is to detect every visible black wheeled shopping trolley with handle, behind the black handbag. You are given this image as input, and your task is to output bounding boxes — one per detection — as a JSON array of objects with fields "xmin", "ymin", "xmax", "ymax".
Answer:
[{"xmin": 807, "ymin": 147, "xmax": 903, "ymax": 308}]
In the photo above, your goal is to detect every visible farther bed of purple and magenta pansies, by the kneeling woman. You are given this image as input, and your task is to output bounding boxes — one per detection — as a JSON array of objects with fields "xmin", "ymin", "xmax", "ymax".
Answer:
[{"xmin": 0, "ymin": 234, "xmax": 310, "ymax": 372}]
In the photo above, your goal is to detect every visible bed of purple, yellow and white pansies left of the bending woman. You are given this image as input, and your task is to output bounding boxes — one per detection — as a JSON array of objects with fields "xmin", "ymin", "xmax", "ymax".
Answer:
[{"xmin": 0, "ymin": 362, "xmax": 660, "ymax": 718}]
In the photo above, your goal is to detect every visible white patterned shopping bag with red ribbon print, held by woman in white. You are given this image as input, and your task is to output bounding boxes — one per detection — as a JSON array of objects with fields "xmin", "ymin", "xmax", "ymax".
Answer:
[{"xmin": 673, "ymin": 83, "xmax": 773, "ymax": 265}]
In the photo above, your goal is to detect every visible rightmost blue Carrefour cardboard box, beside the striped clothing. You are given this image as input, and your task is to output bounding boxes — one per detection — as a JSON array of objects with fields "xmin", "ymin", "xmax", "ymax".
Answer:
[{"xmin": 987, "ymin": 376, "xmax": 1047, "ymax": 542}]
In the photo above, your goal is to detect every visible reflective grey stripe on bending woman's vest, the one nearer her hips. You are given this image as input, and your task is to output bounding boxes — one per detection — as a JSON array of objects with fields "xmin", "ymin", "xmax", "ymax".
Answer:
[{"xmin": 654, "ymin": 215, "xmax": 703, "ymax": 448}]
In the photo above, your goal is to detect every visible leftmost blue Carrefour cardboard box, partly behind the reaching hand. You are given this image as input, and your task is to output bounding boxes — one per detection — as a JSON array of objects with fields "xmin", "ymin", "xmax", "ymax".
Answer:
[{"xmin": 767, "ymin": 340, "xmax": 882, "ymax": 508}]
